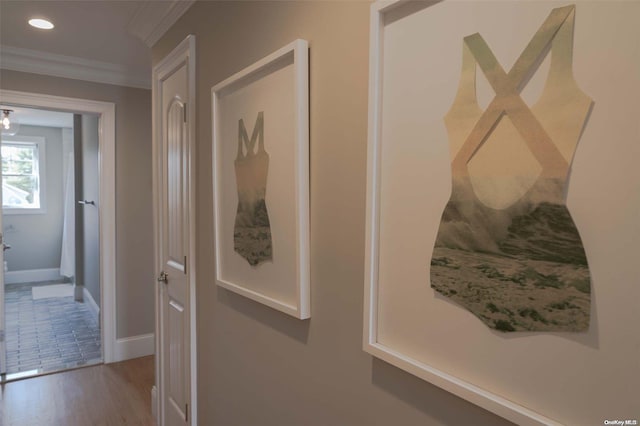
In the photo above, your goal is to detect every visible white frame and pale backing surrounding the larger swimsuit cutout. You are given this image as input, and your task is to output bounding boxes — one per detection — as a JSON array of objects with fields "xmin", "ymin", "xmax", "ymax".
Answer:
[{"xmin": 363, "ymin": 1, "xmax": 640, "ymax": 425}]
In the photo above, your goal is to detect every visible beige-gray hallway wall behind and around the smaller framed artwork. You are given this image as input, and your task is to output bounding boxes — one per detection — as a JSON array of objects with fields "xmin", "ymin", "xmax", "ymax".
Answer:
[{"xmin": 153, "ymin": 2, "xmax": 507, "ymax": 426}]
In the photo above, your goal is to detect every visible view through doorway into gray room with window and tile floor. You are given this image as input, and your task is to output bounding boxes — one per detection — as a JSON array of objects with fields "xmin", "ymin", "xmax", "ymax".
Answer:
[{"xmin": 0, "ymin": 105, "xmax": 103, "ymax": 380}]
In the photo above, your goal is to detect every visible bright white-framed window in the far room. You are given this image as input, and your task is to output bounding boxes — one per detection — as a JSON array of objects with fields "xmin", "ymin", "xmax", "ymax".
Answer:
[{"xmin": 2, "ymin": 136, "xmax": 44, "ymax": 213}]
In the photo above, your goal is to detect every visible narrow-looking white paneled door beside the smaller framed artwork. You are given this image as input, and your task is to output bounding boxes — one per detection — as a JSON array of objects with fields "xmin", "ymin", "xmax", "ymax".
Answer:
[{"xmin": 154, "ymin": 36, "xmax": 194, "ymax": 426}]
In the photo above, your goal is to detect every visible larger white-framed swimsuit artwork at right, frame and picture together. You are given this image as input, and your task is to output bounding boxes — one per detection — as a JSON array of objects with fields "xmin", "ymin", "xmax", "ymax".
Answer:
[{"xmin": 363, "ymin": 0, "xmax": 640, "ymax": 425}]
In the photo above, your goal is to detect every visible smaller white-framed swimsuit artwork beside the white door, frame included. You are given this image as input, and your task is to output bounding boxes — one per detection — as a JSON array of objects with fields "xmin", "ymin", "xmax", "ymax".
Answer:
[{"xmin": 211, "ymin": 39, "xmax": 311, "ymax": 319}]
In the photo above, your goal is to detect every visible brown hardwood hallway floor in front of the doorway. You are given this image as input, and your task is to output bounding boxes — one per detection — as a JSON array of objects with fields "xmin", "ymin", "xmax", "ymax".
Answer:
[{"xmin": 0, "ymin": 356, "xmax": 155, "ymax": 426}]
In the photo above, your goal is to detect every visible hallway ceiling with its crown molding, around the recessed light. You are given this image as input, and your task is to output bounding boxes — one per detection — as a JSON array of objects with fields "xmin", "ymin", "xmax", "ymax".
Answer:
[{"xmin": 0, "ymin": 0, "xmax": 193, "ymax": 87}]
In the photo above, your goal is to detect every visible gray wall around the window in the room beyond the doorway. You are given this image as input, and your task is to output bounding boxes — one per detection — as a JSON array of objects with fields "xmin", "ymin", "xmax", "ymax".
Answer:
[{"xmin": 2, "ymin": 125, "xmax": 64, "ymax": 271}]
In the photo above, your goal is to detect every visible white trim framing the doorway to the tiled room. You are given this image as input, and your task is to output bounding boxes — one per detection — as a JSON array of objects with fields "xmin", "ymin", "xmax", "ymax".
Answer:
[{"xmin": 0, "ymin": 90, "xmax": 116, "ymax": 380}]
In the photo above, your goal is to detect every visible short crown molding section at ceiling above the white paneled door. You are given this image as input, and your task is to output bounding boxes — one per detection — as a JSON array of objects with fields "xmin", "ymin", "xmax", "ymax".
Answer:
[{"xmin": 127, "ymin": 0, "xmax": 195, "ymax": 47}]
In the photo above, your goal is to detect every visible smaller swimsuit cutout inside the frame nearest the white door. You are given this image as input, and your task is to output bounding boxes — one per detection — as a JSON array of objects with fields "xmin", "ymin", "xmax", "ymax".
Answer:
[{"xmin": 233, "ymin": 111, "xmax": 272, "ymax": 266}]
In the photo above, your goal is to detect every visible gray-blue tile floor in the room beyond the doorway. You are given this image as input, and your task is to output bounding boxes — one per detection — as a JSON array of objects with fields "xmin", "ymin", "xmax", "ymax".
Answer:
[{"xmin": 5, "ymin": 281, "xmax": 102, "ymax": 374}]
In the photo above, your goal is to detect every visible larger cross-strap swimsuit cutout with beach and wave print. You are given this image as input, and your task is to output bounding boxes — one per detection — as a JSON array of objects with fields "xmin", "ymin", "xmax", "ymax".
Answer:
[{"xmin": 430, "ymin": 6, "xmax": 593, "ymax": 332}]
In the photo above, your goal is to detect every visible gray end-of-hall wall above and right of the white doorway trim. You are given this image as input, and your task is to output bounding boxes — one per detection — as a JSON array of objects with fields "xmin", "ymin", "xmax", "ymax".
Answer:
[{"xmin": 0, "ymin": 70, "xmax": 155, "ymax": 338}]
